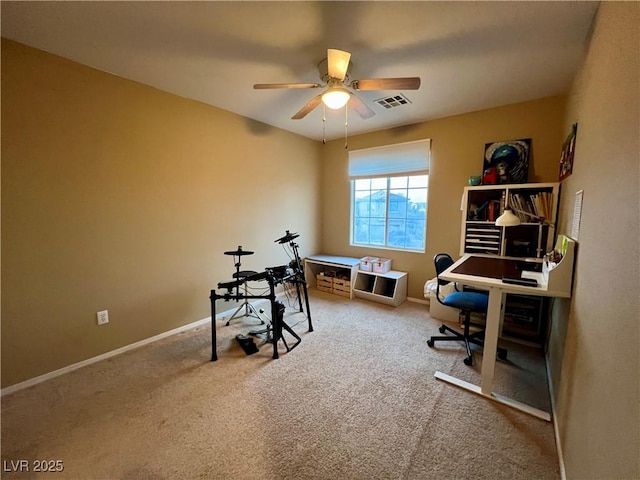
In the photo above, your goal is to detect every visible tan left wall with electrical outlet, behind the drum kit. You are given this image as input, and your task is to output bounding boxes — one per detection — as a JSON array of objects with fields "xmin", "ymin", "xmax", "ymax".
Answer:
[{"xmin": 2, "ymin": 39, "xmax": 320, "ymax": 387}]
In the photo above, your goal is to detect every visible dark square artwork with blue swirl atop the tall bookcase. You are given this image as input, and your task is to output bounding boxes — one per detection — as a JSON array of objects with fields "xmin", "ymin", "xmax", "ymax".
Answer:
[{"xmin": 483, "ymin": 138, "xmax": 531, "ymax": 184}]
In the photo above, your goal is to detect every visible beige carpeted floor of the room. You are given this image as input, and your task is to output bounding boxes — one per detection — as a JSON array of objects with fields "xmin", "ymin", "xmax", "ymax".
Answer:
[{"xmin": 2, "ymin": 290, "xmax": 560, "ymax": 480}]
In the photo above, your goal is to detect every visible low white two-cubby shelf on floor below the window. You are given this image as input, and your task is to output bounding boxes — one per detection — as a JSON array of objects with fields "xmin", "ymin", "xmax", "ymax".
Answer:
[{"xmin": 353, "ymin": 270, "xmax": 407, "ymax": 307}]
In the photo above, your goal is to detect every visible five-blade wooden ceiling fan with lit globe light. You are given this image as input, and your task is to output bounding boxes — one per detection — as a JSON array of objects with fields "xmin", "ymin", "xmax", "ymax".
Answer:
[{"xmin": 253, "ymin": 48, "xmax": 420, "ymax": 120}]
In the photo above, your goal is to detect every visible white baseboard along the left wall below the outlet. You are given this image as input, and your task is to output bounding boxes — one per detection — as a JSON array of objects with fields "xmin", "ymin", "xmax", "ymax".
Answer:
[{"xmin": 0, "ymin": 302, "xmax": 260, "ymax": 397}]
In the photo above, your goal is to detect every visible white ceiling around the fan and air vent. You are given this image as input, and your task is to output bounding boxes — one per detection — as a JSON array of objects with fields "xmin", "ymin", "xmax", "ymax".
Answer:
[{"xmin": 1, "ymin": 1, "xmax": 598, "ymax": 140}]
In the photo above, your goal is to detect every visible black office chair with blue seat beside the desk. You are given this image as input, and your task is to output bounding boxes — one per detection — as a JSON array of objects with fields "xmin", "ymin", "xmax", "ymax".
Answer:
[{"xmin": 427, "ymin": 253, "xmax": 507, "ymax": 365}]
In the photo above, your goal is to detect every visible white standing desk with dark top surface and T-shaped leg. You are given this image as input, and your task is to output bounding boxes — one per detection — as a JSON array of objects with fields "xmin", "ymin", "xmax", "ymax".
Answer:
[{"xmin": 435, "ymin": 236, "xmax": 575, "ymax": 421}]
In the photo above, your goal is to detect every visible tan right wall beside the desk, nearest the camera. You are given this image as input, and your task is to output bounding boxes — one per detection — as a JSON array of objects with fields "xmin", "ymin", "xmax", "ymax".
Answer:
[{"xmin": 548, "ymin": 2, "xmax": 640, "ymax": 479}]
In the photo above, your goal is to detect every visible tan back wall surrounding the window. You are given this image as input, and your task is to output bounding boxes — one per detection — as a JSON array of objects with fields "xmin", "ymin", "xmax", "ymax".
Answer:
[{"xmin": 321, "ymin": 97, "xmax": 565, "ymax": 299}]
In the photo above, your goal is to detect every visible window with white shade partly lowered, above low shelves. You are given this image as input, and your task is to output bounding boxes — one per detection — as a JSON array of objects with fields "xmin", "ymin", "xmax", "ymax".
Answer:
[{"xmin": 349, "ymin": 140, "xmax": 430, "ymax": 252}]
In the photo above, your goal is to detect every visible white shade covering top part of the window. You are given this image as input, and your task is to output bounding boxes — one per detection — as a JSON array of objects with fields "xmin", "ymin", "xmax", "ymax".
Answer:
[{"xmin": 349, "ymin": 139, "xmax": 431, "ymax": 178}]
